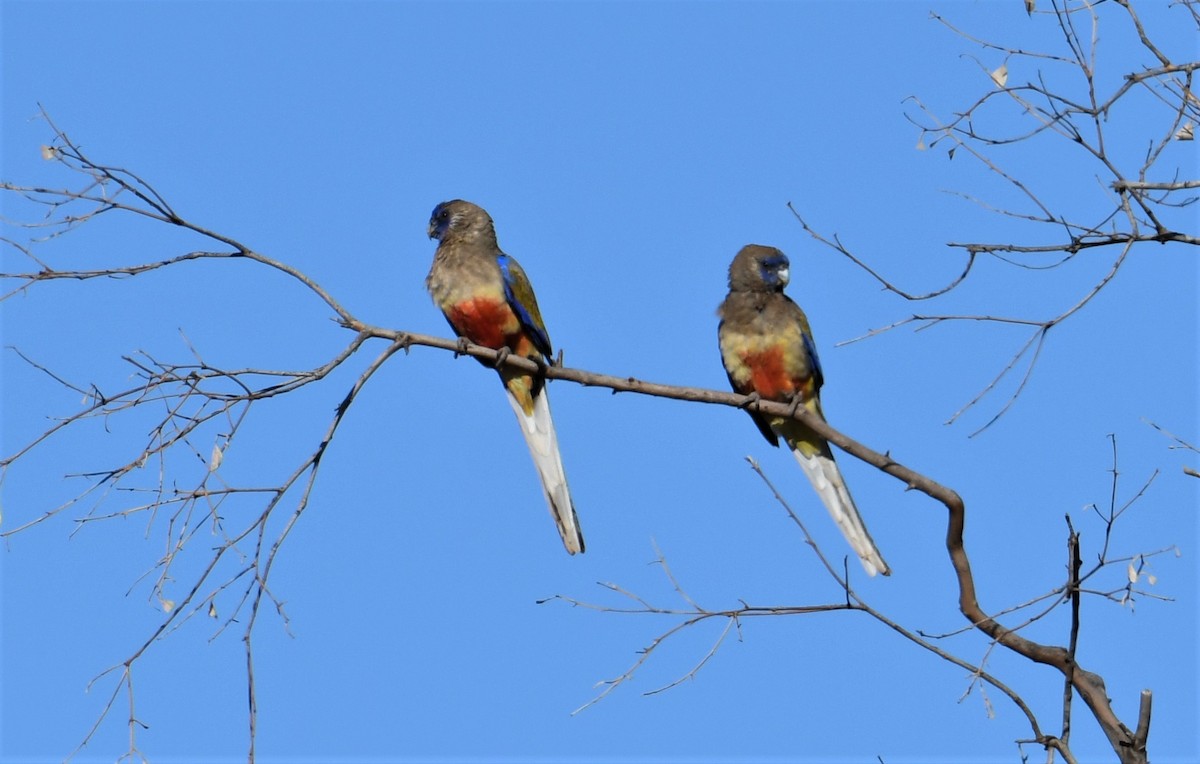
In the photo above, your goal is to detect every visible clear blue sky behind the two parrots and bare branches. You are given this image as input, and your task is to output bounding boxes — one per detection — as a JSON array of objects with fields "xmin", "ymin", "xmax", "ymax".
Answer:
[{"xmin": 0, "ymin": 0, "xmax": 1200, "ymax": 764}]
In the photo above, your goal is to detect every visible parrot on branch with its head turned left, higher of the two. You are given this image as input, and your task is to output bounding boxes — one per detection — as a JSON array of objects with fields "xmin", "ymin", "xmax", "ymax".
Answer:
[{"xmin": 425, "ymin": 199, "xmax": 583, "ymax": 554}]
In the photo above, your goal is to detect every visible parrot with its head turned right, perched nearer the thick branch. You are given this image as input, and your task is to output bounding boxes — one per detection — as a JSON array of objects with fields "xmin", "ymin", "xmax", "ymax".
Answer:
[{"xmin": 716, "ymin": 245, "xmax": 892, "ymax": 576}]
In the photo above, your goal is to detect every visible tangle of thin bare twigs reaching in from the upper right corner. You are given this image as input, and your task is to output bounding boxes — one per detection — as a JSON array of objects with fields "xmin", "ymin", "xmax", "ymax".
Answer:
[{"xmin": 788, "ymin": 0, "xmax": 1200, "ymax": 435}]
